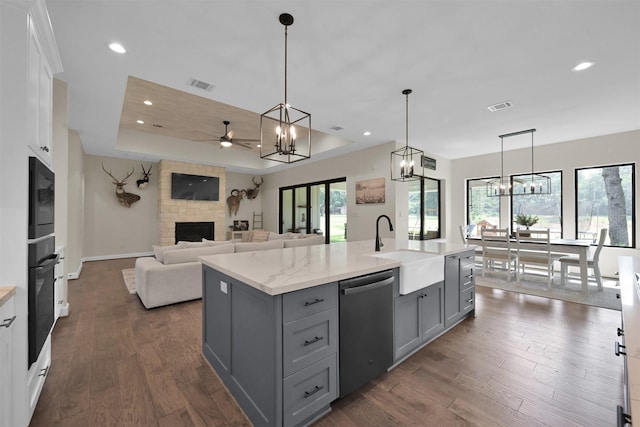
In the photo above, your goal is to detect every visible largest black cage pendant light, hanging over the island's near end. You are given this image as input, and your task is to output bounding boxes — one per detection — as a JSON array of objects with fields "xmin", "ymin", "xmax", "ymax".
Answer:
[{"xmin": 260, "ymin": 13, "xmax": 311, "ymax": 163}]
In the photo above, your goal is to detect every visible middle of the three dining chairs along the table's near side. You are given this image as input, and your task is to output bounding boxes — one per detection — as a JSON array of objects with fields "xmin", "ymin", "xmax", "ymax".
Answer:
[{"xmin": 516, "ymin": 228, "xmax": 562, "ymax": 287}]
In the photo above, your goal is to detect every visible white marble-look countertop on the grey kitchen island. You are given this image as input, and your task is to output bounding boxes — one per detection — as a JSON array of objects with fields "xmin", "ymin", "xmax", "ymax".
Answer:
[{"xmin": 200, "ymin": 238, "xmax": 475, "ymax": 295}]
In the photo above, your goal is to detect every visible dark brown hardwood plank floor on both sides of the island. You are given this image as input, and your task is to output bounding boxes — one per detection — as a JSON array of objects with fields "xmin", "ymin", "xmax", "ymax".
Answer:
[{"xmin": 31, "ymin": 259, "xmax": 623, "ymax": 427}]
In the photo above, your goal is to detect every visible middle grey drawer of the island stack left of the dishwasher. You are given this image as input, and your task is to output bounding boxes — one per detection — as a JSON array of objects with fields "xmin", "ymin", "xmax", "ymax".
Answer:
[{"xmin": 282, "ymin": 308, "xmax": 338, "ymax": 377}]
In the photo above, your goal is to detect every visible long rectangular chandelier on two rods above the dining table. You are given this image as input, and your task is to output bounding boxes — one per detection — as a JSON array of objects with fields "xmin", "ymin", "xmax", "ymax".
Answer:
[{"xmin": 487, "ymin": 129, "xmax": 551, "ymax": 197}]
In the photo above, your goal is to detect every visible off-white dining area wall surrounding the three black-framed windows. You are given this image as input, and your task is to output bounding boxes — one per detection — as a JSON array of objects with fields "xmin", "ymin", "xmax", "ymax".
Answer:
[{"xmin": 448, "ymin": 130, "xmax": 640, "ymax": 276}]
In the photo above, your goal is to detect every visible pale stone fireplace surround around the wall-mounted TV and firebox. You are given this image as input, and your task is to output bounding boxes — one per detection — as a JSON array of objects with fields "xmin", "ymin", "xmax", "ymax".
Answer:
[{"xmin": 158, "ymin": 160, "xmax": 226, "ymax": 246}]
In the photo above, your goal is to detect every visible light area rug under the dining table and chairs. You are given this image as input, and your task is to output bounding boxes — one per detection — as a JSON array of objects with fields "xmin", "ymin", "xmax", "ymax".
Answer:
[{"xmin": 475, "ymin": 274, "xmax": 620, "ymax": 310}]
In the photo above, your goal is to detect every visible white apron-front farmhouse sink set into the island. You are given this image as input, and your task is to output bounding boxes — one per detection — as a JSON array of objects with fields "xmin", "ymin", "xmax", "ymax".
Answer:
[{"xmin": 371, "ymin": 250, "xmax": 444, "ymax": 295}]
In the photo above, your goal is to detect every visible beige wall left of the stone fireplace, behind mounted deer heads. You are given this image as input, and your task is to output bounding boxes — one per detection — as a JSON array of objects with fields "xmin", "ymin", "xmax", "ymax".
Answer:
[{"xmin": 82, "ymin": 156, "xmax": 159, "ymax": 260}]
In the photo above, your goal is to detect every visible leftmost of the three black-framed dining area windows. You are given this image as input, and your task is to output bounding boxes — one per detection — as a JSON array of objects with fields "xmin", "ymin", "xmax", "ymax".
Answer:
[{"xmin": 467, "ymin": 177, "xmax": 502, "ymax": 237}]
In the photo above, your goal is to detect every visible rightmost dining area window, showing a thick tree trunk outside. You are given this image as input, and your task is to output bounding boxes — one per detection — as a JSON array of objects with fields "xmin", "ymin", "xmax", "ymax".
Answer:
[{"xmin": 576, "ymin": 164, "xmax": 636, "ymax": 248}]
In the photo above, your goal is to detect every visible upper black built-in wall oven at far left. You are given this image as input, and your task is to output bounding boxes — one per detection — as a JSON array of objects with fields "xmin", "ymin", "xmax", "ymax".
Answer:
[{"xmin": 29, "ymin": 157, "xmax": 55, "ymax": 239}]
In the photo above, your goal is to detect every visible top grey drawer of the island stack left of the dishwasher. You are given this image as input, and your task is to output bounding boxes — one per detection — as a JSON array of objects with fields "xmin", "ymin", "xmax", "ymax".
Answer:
[{"xmin": 282, "ymin": 283, "xmax": 338, "ymax": 323}]
